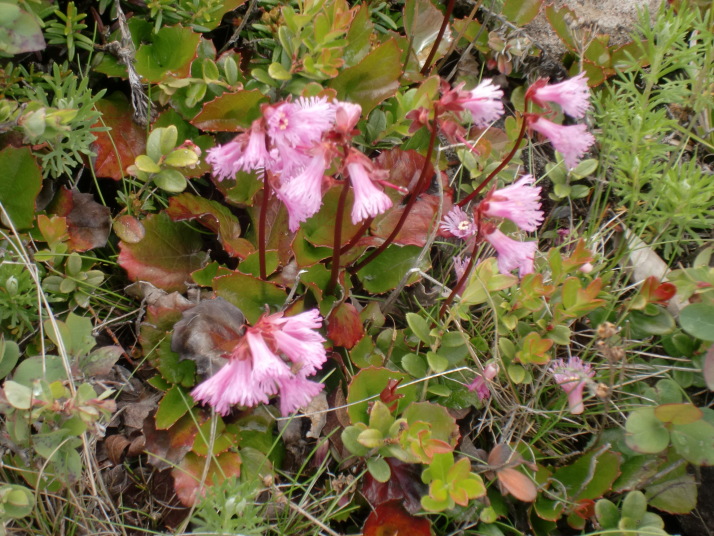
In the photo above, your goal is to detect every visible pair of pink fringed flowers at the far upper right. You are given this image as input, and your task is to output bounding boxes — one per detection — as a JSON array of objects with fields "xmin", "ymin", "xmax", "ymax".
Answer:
[{"xmin": 526, "ymin": 73, "xmax": 595, "ymax": 169}]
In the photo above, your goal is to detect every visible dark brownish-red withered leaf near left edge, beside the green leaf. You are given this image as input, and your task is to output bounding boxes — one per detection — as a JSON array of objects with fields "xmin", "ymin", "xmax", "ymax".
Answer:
[{"xmin": 47, "ymin": 187, "xmax": 112, "ymax": 252}]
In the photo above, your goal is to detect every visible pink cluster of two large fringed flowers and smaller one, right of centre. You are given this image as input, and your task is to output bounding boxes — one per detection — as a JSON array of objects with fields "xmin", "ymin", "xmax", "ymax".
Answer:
[{"xmin": 441, "ymin": 175, "xmax": 543, "ymax": 277}]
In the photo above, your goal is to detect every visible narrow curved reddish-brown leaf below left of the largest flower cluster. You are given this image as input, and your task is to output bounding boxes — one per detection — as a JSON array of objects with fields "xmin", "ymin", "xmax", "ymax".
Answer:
[{"xmin": 166, "ymin": 193, "xmax": 255, "ymax": 259}]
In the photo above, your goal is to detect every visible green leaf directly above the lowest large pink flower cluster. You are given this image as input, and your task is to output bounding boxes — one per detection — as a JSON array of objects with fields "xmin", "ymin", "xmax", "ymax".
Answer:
[{"xmin": 213, "ymin": 272, "xmax": 287, "ymax": 324}]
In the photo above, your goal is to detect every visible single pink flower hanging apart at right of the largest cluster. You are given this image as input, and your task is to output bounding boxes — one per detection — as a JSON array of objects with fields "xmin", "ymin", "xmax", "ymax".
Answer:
[{"xmin": 346, "ymin": 149, "xmax": 392, "ymax": 224}]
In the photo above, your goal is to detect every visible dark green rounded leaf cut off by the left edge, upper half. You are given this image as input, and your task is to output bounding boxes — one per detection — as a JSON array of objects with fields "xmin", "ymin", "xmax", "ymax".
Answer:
[{"xmin": 0, "ymin": 147, "xmax": 42, "ymax": 229}]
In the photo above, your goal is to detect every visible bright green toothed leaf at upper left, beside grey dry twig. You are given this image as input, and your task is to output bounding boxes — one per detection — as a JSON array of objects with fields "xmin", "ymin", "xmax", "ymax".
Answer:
[{"xmin": 136, "ymin": 26, "xmax": 201, "ymax": 83}]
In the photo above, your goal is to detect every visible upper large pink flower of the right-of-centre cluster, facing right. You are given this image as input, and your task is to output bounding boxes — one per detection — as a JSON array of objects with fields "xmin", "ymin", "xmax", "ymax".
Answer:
[{"xmin": 479, "ymin": 175, "xmax": 543, "ymax": 231}]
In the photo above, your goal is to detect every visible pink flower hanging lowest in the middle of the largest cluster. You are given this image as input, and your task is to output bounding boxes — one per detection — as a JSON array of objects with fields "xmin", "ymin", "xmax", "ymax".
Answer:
[{"xmin": 275, "ymin": 149, "xmax": 327, "ymax": 232}]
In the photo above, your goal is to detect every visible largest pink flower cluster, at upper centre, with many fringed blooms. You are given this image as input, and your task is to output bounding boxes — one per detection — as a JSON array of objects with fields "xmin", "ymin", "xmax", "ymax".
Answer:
[{"xmin": 206, "ymin": 97, "xmax": 392, "ymax": 231}]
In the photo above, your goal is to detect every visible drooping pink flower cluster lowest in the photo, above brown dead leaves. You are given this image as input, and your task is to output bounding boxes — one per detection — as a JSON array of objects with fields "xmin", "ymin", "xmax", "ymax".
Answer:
[{"xmin": 191, "ymin": 309, "xmax": 327, "ymax": 416}]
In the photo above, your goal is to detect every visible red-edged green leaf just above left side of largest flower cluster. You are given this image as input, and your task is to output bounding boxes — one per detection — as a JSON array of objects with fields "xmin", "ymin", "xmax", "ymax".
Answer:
[{"xmin": 191, "ymin": 89, "xmax": 267, "ymax": 132}]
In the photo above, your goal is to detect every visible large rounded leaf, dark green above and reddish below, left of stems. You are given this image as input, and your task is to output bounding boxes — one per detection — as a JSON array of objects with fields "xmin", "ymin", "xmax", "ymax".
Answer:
[{"xmin": 117, "ymin": 213, "xmax": 208, "ymax": 291}]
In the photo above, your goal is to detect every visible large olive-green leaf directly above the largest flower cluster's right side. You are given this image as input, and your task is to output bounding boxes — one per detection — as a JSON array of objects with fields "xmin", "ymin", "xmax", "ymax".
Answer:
[{"xmin": 328, "ymin": 39, "xmax": 402, "ymax": 116}]
